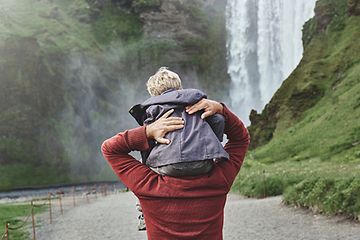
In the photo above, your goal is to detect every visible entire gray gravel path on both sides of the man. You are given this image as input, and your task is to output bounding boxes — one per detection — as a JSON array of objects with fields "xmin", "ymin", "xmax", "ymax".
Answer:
[{"xmin": 37, "ymin": 193, "xmax": 360, "ymax": 240}]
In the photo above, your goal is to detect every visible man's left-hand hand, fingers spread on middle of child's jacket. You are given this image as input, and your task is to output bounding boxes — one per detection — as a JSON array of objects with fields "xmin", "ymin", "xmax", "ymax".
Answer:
[{"xmin": 146, "ymin": 109, "xmax": 184, "ymax": 144}]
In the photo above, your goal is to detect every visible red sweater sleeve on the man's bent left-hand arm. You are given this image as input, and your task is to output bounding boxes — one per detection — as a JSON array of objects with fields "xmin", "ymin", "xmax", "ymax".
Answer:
[{"xmin": 101, "ymin": 126, "xmax": 154, "ymax": 192}]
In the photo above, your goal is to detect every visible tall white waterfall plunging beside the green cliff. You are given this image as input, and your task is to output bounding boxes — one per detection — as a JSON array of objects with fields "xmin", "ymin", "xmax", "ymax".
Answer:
[{"xmin": 226, "ymin": 0, "xmax": 316, "ymax": 124}]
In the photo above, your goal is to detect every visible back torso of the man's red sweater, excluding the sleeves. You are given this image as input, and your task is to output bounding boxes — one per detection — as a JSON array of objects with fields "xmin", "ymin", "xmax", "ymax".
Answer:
[{"xmin": 135, "ymin": 167, "xmax": 229, "ymax": 239}]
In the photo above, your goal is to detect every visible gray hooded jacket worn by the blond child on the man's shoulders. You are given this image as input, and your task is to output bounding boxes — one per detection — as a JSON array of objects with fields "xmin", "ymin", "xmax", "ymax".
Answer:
[{"xmin": 129, "ymin": 89, "xmax": 229, "ymax": 167}]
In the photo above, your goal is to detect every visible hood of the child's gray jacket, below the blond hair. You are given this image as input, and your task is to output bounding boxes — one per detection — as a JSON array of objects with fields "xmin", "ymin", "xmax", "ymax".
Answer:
[{"xmin": 129, "ymin": 89, "xmax": 207, "ymax": 125}]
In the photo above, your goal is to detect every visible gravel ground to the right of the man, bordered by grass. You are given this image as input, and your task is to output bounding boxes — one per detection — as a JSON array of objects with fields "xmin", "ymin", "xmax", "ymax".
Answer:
[{"xmin": 224, "ymin": 195, "xmax": 360, "ymax": 240}]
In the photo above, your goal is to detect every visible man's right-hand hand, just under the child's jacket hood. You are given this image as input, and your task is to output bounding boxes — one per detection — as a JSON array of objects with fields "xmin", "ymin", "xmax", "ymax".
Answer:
[{"xmin": 186, "ymin": 98, "xmax": 224, "ymax": 119}]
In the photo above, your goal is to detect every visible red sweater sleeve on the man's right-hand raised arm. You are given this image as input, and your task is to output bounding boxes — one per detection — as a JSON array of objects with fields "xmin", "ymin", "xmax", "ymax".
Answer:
[{"xmin": 220, "ymin": 105, "xmax": 250, "ymax": 188}]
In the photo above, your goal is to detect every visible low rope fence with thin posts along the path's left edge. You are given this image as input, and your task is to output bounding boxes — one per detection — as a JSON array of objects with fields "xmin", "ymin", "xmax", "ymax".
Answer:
[{"xmin": 0, "ymin": 185, "xmax": 120, "ymax": 240}]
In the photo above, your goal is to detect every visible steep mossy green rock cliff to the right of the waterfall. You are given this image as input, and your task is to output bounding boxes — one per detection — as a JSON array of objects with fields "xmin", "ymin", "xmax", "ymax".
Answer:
[{"xmin": 249, "ymin": 0, "xmax": 360, "ymax": 156}]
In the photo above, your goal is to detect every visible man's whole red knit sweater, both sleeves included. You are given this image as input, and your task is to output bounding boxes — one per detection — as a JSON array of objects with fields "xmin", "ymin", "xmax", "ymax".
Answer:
[{"xmin": 101, "ymin": 106, "xmax": 249, "ymax": 240}]
